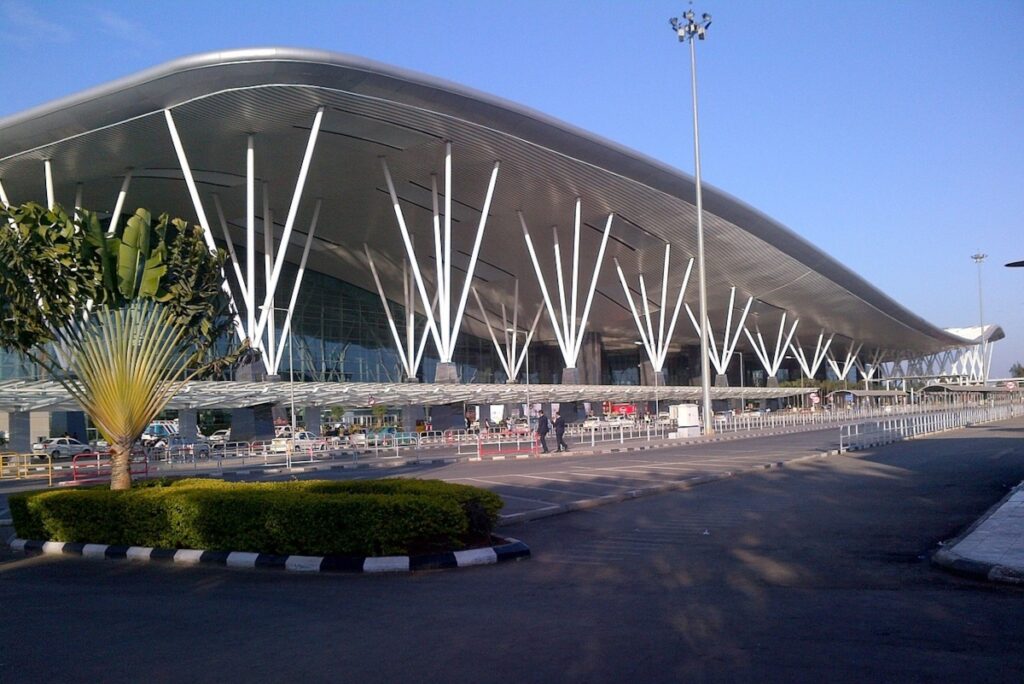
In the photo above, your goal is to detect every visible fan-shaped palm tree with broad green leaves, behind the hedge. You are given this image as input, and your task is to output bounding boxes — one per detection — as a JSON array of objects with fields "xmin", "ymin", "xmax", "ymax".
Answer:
[{"xmin": 0, "ymin": 203, "xmax": 247, "ymax": 489}]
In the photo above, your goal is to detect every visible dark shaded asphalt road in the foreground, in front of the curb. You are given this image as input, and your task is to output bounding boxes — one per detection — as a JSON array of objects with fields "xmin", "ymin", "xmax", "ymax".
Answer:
[{"xmin": 0, "ymin": 421, "xmax": 1024, "ymax": 682}]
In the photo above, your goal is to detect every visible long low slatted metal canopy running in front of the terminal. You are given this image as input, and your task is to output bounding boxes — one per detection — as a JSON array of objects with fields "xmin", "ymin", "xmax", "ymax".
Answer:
[{"xmin": 0, "ymin": 380, "xmax": 816, "ymax": 412}]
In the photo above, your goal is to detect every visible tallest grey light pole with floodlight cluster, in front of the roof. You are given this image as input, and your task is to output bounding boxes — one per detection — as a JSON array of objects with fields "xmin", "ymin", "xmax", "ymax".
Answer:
[{"xmin": 669, "ymin": 9, "xmax": 715, "ymax": 434}]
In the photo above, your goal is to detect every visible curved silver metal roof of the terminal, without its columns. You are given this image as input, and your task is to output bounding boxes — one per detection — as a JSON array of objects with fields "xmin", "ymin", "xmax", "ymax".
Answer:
[{"xmin": 0, "ymin": 48, "xmax": 964, "ymax": 353}]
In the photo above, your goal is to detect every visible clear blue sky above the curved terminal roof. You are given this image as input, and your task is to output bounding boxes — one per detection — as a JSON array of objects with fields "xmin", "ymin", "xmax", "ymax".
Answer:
[{"xmin": 0, "ymin": 0, "xmax": 1024, "ymax": 377}]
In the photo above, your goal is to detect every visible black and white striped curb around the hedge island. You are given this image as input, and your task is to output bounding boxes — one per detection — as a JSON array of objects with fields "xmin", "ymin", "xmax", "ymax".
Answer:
[{"xmin": 9, "ymin": 538, "xmax": 529, "ymax": 572}]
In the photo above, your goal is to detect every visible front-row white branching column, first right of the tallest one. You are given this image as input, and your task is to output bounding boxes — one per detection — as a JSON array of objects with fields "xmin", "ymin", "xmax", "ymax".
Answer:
[{"xmin": 381, "ymin": 142, "xmax": 501, "ymax": 364}]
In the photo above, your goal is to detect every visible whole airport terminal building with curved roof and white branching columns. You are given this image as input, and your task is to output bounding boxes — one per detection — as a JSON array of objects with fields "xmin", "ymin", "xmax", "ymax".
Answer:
[{"xmin": 0, "ymin": 48, "xmax": 1002, "ymax": 444}]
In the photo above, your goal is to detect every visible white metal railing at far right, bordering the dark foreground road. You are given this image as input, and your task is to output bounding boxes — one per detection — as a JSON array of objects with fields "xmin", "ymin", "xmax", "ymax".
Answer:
[{"xmin": 839, "ymin": 404, "xmax": 1024, "ymax": 452}]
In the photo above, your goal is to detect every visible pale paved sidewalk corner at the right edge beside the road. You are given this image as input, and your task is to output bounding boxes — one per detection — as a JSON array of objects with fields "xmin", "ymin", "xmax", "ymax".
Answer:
[{"xmin": 932, "ymin": 482, "xmax": 1024, "ymax": 585}]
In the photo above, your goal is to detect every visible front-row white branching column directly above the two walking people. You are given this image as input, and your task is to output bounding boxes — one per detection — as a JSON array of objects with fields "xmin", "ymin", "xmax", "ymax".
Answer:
[{"xmin": 516, "ymin": 199, "xmax": 615, "ymax": 370}]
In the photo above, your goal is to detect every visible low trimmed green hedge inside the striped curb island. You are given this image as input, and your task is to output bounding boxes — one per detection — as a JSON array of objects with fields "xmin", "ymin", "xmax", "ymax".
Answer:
[{"xmin": 8, "ymin": 478, "xmax": 503, "ymax": 556}]
